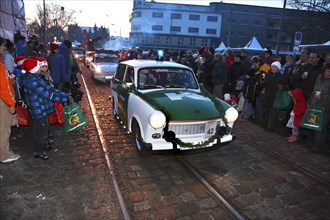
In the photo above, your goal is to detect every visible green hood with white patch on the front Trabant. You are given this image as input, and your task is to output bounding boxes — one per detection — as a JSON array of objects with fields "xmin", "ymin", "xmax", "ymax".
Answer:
[{"xmin": 144, "ymin": 90, "xmax": 229, "ymax": 120}]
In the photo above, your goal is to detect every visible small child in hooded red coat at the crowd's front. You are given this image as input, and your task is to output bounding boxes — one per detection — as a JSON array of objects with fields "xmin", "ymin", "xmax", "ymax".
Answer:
[{"xmin": 287, "ymin": 88, "xmax": 307, "ymax": 143}]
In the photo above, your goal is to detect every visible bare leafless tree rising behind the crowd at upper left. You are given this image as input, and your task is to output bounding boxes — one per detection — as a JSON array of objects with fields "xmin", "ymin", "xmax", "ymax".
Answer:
[{"xmin": 27, "ymin": 3, "xmax": 77, "ymax": 41}]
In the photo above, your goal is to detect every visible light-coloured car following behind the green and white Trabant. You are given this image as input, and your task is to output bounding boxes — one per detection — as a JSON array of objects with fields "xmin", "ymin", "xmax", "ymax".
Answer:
[{"xmin": 89, "ymin": 50, "xmax": 118, "ymax": 81}]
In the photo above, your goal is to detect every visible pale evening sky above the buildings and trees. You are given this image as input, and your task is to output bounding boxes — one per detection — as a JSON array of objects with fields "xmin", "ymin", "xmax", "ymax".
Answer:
[{"xmin": 24, "ymin": 0, "xmax": 283, "ymax": 37}]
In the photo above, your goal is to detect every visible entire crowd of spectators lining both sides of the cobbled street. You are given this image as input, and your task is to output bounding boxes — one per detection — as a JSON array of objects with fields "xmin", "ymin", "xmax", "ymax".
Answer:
[{"xmin": 0, "ymin": 32, "xmax": 330, "ymax": 163}]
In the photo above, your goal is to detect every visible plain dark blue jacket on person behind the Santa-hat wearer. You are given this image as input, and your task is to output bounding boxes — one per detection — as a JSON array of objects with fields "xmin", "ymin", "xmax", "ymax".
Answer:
[{"xmin": 50, "ymin": 43, "xmax": 72, "ymax": 84}]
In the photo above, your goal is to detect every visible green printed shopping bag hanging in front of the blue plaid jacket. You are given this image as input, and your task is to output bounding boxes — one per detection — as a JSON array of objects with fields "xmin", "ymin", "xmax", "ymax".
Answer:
[{"xmin": 62, "ymin": 96, "xmax": 87, "ymax": 133}]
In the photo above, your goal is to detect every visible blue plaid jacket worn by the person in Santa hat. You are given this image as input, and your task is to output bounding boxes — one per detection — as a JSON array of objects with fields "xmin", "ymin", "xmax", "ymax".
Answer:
[{"xmin": 21, "ymin": 73, "xmax": 69, "ymax": 118}]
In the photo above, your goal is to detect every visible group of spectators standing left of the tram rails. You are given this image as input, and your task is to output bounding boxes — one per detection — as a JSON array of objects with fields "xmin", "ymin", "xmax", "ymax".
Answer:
[{"xmin": 0, "ymin": 31, "xmax": 82, "ymax": 163}]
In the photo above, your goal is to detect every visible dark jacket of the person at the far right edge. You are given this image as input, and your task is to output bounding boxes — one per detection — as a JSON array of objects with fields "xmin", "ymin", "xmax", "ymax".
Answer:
[{"xmin": 308, "ymin": 74, "xmax": 330, "ymax": 110}]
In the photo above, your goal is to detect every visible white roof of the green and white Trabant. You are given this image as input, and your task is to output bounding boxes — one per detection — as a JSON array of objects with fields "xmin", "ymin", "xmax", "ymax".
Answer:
[{"xmin": 120, "ymin": 60, "xmax": 191, "ymax": 70}]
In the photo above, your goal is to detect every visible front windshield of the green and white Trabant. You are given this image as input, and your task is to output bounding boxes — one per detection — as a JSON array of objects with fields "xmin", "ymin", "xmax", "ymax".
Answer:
[{"xmin": 138, "ymin": 67, "xmax": 198, "ymax": 89}]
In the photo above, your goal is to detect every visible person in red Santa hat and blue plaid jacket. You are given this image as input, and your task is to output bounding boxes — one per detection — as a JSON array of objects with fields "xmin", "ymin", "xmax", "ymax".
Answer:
[{"xmin": 21, "ymin": 58, "xmax": 69, "ymax": 160}]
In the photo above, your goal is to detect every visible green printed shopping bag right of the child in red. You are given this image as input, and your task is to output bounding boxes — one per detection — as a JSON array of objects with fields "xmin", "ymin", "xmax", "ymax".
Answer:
[{"xmin": 299, "ymin": 101, "xmax": 324, "ymax": 131}]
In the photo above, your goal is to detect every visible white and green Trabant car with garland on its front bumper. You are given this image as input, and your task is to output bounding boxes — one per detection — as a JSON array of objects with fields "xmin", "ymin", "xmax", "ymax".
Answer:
[{"xmin": 111, "ymin": 60, "xmax": 238, "ymax": 152}]
